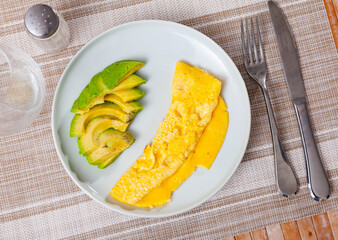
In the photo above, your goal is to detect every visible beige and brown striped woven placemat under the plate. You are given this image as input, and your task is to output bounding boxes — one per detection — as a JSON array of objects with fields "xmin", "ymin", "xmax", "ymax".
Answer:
[{"xmin": 0, "ymin": 0, "xmax": 338, "ymax": 239}]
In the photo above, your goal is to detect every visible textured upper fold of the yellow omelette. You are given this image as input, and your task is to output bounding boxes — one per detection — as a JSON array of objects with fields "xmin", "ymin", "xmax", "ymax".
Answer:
[{"xmin": 110, "ymin": 62, "xmax": 225, "ymax": 207}]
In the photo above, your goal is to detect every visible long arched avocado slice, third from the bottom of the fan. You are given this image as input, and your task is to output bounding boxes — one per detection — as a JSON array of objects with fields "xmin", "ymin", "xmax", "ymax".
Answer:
[{"xmin": 70, "ymin": 102, "xmax": 136, "ymax": 137}]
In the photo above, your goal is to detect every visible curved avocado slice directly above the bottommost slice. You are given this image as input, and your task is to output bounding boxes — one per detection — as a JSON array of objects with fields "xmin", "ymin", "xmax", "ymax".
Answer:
[{"xmin": 77, "ymin": 116, "xmax": 130, "ymax": 155}]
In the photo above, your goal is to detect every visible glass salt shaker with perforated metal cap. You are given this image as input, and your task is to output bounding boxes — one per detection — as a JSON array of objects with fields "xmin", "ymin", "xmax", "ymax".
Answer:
[{"xmin": 25, "ymin": 4, "xmax": 70, "ymax": 52}]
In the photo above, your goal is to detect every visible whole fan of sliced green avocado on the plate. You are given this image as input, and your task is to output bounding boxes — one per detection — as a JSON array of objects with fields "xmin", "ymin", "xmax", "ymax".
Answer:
[{"xmin": 70, "ymin": 60, "xmax": 146, "ymax": 168}]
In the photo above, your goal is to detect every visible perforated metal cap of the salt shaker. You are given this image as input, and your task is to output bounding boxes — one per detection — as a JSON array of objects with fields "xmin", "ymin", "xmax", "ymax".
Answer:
[{"xmin": 25, "ymin": 4, "xmax": 59, "ymax": 39}]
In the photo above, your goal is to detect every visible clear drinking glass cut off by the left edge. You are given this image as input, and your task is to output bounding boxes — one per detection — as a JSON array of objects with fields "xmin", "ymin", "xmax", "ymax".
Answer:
[{"xmin": 0, "ymin": 43, "xmax": 46, "ymax": 136}]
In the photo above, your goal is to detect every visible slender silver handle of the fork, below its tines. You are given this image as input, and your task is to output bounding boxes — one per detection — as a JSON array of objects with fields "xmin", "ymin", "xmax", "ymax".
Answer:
[{"xmin": 261, "ymin": 86, "xmax": 298, "ymax": 197}]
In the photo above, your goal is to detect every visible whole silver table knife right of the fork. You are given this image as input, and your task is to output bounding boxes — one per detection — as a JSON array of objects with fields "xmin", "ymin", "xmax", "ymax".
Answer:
[{"xmin": 268, "ymin": 0, "xmax": 330, "ymax": 201}]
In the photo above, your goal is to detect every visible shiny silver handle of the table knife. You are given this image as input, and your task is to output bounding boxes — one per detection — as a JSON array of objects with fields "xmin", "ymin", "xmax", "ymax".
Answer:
[{"xmin": 294, "ymin": 99, "xmax": 330, "ymax": 201}]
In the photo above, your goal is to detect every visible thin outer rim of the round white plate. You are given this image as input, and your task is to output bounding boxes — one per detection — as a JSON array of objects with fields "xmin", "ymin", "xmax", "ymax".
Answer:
[{"xmin": 51, "ymin": 20, "xmax": 251, "ymax": 218}]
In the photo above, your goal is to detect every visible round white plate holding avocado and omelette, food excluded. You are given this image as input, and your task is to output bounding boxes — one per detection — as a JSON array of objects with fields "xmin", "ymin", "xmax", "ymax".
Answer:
[{"xmin": 52, "ymin": 21, "xmax": 251, "ymax": 217}]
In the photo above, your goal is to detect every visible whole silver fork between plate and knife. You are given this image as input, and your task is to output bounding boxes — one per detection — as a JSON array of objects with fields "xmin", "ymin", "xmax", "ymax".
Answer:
[{"xmin": 241, "ymin": 16, "xmax": 298, "ymax": 197}]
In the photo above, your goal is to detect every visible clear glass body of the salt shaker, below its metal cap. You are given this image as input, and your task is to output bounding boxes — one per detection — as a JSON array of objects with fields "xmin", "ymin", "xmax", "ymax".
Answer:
[{"xmin": 28, "ymin": 12, "xmax": 70, "ymax": 52}]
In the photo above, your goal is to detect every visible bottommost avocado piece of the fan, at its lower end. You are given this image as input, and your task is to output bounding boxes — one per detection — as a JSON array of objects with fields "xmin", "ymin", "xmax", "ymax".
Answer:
[{"xmin": 87, "ymin": 128, "xmax": 135, "ymax": 168}]
